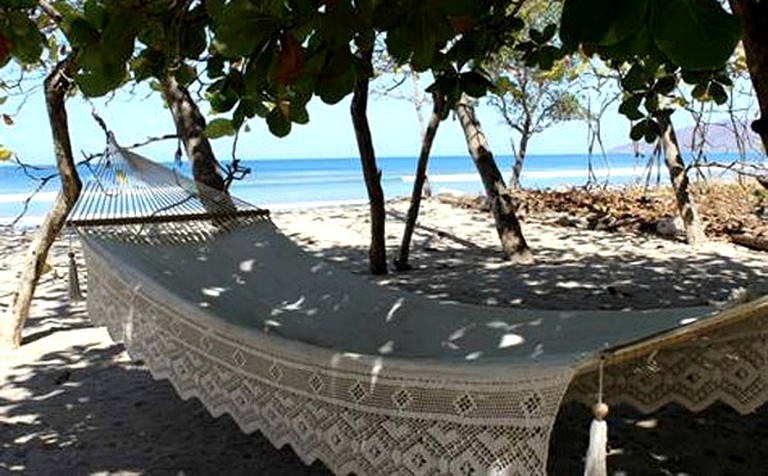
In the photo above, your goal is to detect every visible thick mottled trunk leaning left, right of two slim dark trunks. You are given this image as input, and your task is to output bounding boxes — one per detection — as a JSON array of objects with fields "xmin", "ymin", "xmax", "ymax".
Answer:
[{"xmin": 456, "ymin": 95, "xmax": 533, "ymax": 263}]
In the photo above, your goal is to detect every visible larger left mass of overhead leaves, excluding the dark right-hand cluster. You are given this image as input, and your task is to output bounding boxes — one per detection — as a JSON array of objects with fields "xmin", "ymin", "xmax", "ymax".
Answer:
[{"xmin": 0, "ymin": 0, "xmax": 523, "ymax": 136}]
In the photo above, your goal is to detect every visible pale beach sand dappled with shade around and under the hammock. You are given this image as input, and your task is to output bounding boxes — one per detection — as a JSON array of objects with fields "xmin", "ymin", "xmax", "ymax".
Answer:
[{"xmin": 0, "ymin": 200, "xmax": 768, "ymax": 475}]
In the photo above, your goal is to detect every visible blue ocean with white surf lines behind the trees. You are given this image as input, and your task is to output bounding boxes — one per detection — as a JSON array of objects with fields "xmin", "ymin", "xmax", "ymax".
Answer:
[{"xmin": 0, "ymin": 154, "xmax": 764, "ymax": 225}]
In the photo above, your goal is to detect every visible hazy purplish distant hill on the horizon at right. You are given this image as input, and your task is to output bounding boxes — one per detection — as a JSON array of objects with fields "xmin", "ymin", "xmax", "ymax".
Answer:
[{"xmin": 609, "ymin": 122, "xmax": 762, "ymax": 154}]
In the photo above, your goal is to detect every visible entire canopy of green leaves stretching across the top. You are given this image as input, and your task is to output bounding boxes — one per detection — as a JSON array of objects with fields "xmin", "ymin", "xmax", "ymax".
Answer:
[{"xmin": 0, "ymin": 0, "xmax": 740, "ymax": 147}]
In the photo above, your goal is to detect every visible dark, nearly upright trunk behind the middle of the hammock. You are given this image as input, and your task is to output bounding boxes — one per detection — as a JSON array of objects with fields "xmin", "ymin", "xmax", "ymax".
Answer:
[{"xmin": 350, "ymin": 47, "xmax": 387, "ymax": 275}]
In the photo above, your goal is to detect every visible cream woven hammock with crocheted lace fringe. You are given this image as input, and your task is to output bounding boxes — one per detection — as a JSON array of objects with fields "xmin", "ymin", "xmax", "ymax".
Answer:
[{"xmin": 70, "ymin": 135, "xmax": 768, "ymax": 475}]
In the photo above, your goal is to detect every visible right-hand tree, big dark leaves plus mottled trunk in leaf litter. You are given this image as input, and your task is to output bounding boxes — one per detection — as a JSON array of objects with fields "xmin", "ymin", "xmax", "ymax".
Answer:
[{"xmin": 561, "ymin": 0, "xmax": 740, "ymax": 244}]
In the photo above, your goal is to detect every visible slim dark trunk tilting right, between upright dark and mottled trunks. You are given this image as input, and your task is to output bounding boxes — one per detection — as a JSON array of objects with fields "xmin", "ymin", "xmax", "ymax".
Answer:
[{"xmin": 395, "ymin": 93, "xmax": 445, "ymax": 271}]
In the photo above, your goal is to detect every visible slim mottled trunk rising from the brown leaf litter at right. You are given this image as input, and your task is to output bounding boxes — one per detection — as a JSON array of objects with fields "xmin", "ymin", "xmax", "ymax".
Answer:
[{"xmin": 659, "ymin": 116, "xmax": 706, "ymax": 245}]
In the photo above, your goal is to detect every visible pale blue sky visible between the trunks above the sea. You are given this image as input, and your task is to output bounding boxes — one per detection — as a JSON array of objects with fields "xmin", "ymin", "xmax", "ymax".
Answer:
[{"xmin": 0, "ymin": 72, "xmax": 629, "ymax": 164}]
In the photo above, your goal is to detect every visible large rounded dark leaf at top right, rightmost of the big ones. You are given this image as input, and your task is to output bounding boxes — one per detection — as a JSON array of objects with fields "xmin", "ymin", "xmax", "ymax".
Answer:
[{"xmin": 650, "ymin": 0, "xmax": 741, "ymax": 70}]
